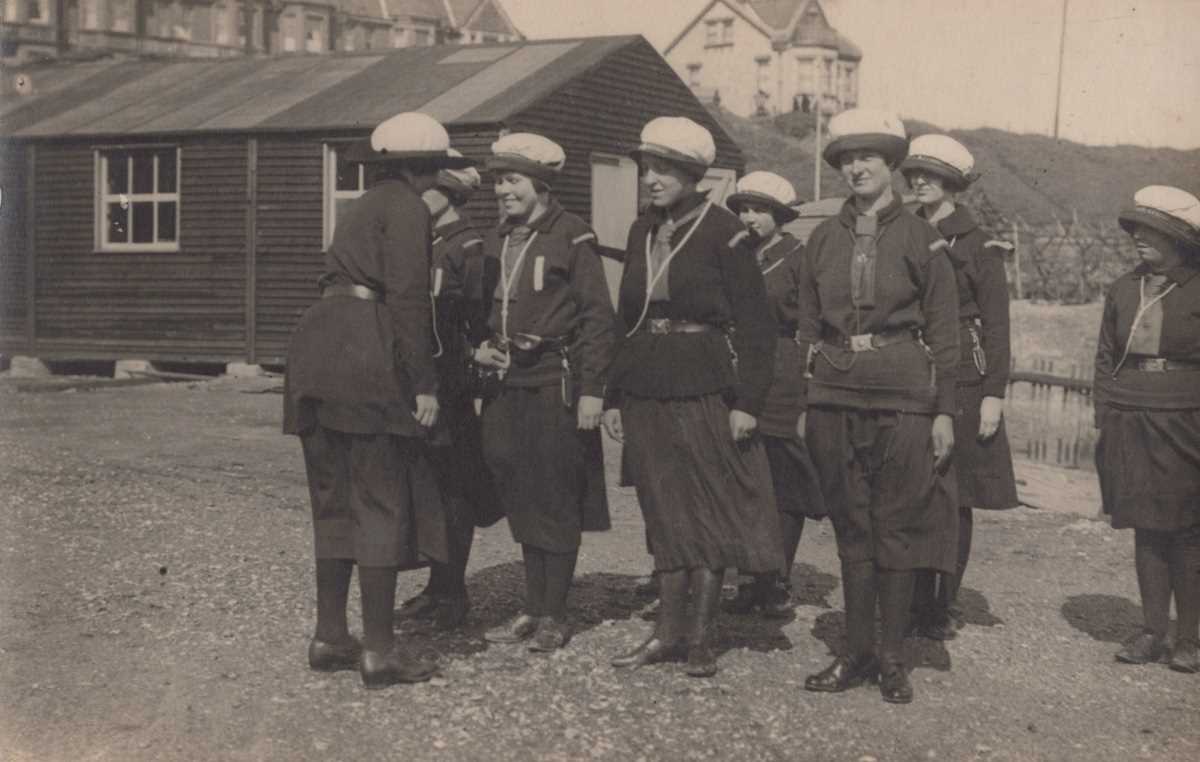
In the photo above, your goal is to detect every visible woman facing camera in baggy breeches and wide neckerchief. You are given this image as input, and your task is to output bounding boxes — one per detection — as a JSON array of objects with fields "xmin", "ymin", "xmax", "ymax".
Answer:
[{"xmin": 797, "ymin": 109, "xmax": 959, "ymax": 703}]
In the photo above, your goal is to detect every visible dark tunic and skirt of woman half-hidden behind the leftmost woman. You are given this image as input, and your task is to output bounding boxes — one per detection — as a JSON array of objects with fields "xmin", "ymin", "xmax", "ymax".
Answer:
[{"xmin": 431, "ymin": 218, "xmax": 504, "ymax": 527}]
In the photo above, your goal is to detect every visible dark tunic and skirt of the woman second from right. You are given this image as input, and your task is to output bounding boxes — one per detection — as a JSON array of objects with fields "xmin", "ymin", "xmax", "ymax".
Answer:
[{"xmin": 917, "ymin": 206, "xmax": 1020, "ymax": 509}]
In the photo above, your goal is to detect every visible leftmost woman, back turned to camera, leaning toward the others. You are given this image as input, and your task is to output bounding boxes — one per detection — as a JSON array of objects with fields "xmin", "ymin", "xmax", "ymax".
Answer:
[{"xmin": 283, "ymin": 113, "xmax": 470, "ymax": 688}]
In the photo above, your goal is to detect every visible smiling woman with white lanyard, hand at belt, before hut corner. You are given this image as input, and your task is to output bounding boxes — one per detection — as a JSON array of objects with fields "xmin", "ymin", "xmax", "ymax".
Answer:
[{"xmin": 475, "ymin": 133, "xmax": 616, "ymax": 652}]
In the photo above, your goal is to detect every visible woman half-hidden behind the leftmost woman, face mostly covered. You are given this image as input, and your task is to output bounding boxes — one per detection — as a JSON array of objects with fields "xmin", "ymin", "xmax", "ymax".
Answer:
[{"xmin": 397, "ymin": 150, "xmax": 503, "ymax": 630}]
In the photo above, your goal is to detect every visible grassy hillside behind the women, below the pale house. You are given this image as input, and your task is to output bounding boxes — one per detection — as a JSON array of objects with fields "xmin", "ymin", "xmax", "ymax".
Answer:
[{"xmin": 716, "ymin": 110, "xmax": 1200, "ymax": 224}]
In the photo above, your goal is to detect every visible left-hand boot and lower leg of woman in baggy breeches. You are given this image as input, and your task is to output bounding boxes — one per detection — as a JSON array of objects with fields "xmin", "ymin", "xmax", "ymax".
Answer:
[{"xmin": 804, "ymin": 560, "xmax": 880, "ymax": 694}]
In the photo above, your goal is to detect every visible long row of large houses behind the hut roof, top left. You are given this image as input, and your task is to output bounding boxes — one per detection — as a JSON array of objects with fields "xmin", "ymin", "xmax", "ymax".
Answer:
[{"xmin": 0, "ymin": 0, "xmax": 523, "ymax": 62}]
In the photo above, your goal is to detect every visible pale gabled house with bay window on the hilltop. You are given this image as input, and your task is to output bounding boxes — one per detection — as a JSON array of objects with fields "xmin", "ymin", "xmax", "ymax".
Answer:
[{"xmin": 662, "ymin": 0, "xmax": 863, "ymax": 116}]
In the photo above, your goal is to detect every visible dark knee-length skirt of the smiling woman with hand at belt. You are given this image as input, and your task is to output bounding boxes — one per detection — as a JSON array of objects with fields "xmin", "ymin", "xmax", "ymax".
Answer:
[{"xmin": 482, "ymin": 384, "xmax": 611, "ymax": 553}]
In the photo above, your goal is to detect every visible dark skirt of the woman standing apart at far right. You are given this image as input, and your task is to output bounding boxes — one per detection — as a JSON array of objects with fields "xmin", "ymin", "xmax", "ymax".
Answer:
[{"xmin": 1096, "ymin": 406, "xmax": 1200, "ymax": 530}]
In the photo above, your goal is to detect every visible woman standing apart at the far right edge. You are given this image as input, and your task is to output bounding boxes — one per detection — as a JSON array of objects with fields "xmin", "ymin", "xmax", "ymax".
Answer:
[{"xmin": 1094, "ymin": 185, "xmax": 1200, "ymax": 672}]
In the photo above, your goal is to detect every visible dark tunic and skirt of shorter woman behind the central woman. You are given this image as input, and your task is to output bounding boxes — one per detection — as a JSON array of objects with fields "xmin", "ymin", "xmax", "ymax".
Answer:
[{"xmin": 758, "ymin": 233, "xmax": 826, "ymax": 518}]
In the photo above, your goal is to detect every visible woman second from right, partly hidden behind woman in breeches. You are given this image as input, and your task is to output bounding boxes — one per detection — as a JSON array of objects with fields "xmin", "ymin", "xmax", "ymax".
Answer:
[{"xmin": 900, "ymin": 134, "xmax": 1019, "ymax": 641}]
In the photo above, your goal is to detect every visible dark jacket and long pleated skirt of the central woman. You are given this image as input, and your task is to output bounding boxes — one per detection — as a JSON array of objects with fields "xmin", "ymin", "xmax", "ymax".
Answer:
[{"xmin": 608, "ymin": 194, "xmax": 784, "ymax": 572}]
